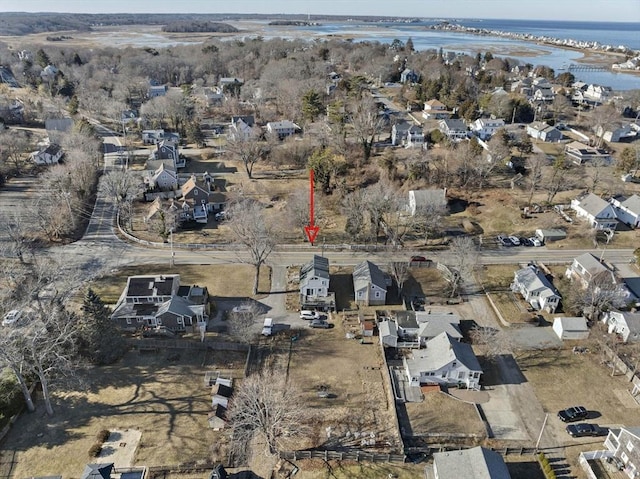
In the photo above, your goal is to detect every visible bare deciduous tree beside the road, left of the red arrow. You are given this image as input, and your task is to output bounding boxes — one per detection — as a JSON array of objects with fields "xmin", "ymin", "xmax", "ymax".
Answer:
[{"xmin": 228, "ymin": 199, "xmax": 276, "ymax": 294}]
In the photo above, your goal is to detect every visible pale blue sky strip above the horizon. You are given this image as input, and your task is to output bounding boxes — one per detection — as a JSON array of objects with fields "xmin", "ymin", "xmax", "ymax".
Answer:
[{"xmin": 0, "ymin": 0, "xmax": 640, "ymax": 23}]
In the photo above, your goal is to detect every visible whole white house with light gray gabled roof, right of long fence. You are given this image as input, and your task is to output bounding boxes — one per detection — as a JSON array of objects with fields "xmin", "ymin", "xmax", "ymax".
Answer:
[{"xmin": 403, "ymin": 333, "xmax": 482, "ymax": 389}]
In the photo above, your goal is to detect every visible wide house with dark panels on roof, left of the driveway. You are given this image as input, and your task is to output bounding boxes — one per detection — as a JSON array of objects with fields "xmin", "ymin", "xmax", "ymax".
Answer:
[{"xmin": 111, "ymin": 274, "xmax": 209, "ymax": 331}]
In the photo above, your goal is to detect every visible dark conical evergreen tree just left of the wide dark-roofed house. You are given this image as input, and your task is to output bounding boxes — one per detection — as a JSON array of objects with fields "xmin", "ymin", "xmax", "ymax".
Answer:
[{"xmin": 78, "ymin": 288, "xmax": 126, "ymax": 364}]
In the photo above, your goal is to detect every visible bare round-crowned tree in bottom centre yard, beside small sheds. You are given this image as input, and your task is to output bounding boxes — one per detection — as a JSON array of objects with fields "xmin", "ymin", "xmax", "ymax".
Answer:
[{"xmin": 227, "ymin": 371, "xmax": 307, "ymax": 455}]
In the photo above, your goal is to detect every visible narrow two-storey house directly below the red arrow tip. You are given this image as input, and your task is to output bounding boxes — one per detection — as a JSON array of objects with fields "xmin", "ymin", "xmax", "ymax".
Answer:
[{"xmin": 300, "ymin": 255, "xmax": 335, "ymax": 310}]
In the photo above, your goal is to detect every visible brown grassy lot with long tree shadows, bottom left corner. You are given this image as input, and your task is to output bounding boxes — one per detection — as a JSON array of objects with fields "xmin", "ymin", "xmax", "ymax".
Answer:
[{"xmin": 0, "ymin": 351, "xmax": 245, "ymax": 478}]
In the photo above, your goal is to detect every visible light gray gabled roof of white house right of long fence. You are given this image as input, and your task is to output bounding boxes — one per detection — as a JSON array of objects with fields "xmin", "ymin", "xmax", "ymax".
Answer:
[{"xmin": 407, "ymin": 333, "xmax": 482, "ymax": 371}]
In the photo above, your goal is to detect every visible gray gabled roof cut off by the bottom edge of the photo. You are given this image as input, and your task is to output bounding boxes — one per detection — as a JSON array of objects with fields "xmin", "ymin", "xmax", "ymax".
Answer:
[{"xmin": 433, "ymin": 447, "xmax": 511, "ymax": 479}]
